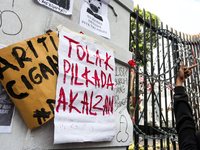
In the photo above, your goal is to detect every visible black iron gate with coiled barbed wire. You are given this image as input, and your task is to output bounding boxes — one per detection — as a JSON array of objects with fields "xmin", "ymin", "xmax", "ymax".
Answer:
[{"xmin": 130, "ymin": 5, "xmax": 200, "ymax": 150}]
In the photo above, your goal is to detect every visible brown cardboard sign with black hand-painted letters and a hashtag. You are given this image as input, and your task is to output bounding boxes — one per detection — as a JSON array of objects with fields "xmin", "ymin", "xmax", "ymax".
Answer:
[{"xmin": 0, "ymin": 32, "xmax": 58, "ymax": 129}]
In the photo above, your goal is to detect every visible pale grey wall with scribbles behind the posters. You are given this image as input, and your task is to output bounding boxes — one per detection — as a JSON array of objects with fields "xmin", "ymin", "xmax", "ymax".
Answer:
[{"xmin": 0, "ymin": 0, "xmax": 133, "ymax": 150}]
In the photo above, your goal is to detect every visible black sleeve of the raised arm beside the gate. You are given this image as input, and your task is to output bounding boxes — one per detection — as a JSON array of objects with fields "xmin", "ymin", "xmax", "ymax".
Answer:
[{"xmin": 174, "ymin": 86, "xmax": 198, "ymax": 150}]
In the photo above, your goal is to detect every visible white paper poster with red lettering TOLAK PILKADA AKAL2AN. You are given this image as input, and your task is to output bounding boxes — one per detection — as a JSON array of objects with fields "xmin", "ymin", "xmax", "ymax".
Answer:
[{"xmin": 54, "ymin": 30, "xmax": 115, "ymax": 144}]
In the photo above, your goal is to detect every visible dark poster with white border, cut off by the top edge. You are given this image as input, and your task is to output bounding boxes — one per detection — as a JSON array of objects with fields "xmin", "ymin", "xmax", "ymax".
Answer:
[{"xmin": 37, "ymin": 0, "xmax": 74, "ymax": 15}]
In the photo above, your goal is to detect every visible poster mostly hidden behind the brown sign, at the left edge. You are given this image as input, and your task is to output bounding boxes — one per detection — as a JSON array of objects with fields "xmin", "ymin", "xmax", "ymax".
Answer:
[{"xmin": 0, "ymin": 44, "xmax": 15, "ymax": 133}]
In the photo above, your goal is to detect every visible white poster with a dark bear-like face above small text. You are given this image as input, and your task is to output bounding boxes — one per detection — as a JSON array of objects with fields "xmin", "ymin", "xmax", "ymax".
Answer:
[{"xmin": 79, "ymin": 0, "xmax": 110, "ymax": 39}]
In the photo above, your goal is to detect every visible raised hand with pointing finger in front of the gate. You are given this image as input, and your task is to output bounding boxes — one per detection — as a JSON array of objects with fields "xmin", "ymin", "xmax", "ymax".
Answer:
[{"xmin": 176, "ymin": 62, "xmax": 197, "ymax": 86}]
